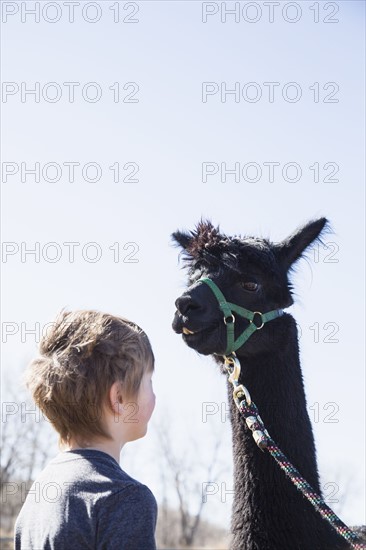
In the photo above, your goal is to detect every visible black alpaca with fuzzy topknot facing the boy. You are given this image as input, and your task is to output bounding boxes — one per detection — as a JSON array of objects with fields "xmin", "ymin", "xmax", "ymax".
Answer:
[{"xmin": 173, "ymin": 218, "xmax": 360, "ymax": 550}]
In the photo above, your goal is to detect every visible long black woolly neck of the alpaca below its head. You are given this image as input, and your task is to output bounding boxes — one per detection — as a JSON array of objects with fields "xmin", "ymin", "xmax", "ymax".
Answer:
[{"xmin": 229, "ymin": 315, "xmax": 344, "ymax": 550}]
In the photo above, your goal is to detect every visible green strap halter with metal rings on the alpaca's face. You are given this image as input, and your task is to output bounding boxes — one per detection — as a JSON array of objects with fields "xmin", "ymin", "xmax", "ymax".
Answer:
[{"xmin": 197, "ymin": 277, "xmax": 283, "ymax": 355}]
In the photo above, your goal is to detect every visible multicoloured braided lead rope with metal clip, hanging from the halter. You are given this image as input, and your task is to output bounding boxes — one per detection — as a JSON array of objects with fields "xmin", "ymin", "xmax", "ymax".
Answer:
[{"xmin": 224, "ymin": 354, "xmax": 366, "ymax": 550}]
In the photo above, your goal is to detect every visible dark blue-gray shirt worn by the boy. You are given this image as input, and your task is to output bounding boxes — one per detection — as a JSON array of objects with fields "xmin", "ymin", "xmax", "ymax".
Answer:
[{"xmin": 15, "ymin": 449, "xmax": 157, "ymax": 550}]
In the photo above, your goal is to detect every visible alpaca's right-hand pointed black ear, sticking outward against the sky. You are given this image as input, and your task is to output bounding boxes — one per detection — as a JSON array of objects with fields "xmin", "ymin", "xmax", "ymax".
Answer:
[{"xmin": 276, "ymin": 218, "xmax": 328, "ymax": 271}]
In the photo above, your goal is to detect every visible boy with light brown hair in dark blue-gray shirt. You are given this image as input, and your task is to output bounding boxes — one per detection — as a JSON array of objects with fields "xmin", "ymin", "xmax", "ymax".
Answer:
[{"xmin": 15, "ymin": 311, "xmax": 157, "ymax": 550}]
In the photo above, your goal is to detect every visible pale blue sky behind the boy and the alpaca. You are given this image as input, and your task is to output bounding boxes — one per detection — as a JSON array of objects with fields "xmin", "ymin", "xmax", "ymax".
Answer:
[{"xmin": 2, "ymin": 1, "xmax": 365, "ymax": 524}]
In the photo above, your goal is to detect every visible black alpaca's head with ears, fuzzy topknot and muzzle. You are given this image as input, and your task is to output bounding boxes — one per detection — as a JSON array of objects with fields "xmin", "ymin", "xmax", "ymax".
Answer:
[{"xmin": 172, "ymin": 218, "xmax": 327, "ymax": 355}]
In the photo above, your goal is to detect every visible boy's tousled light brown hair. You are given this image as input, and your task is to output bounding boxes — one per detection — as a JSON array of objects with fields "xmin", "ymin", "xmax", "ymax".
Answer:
[{"xmin": 26, "ymin": 311, "xmax": 154, "ymax": 445}]
